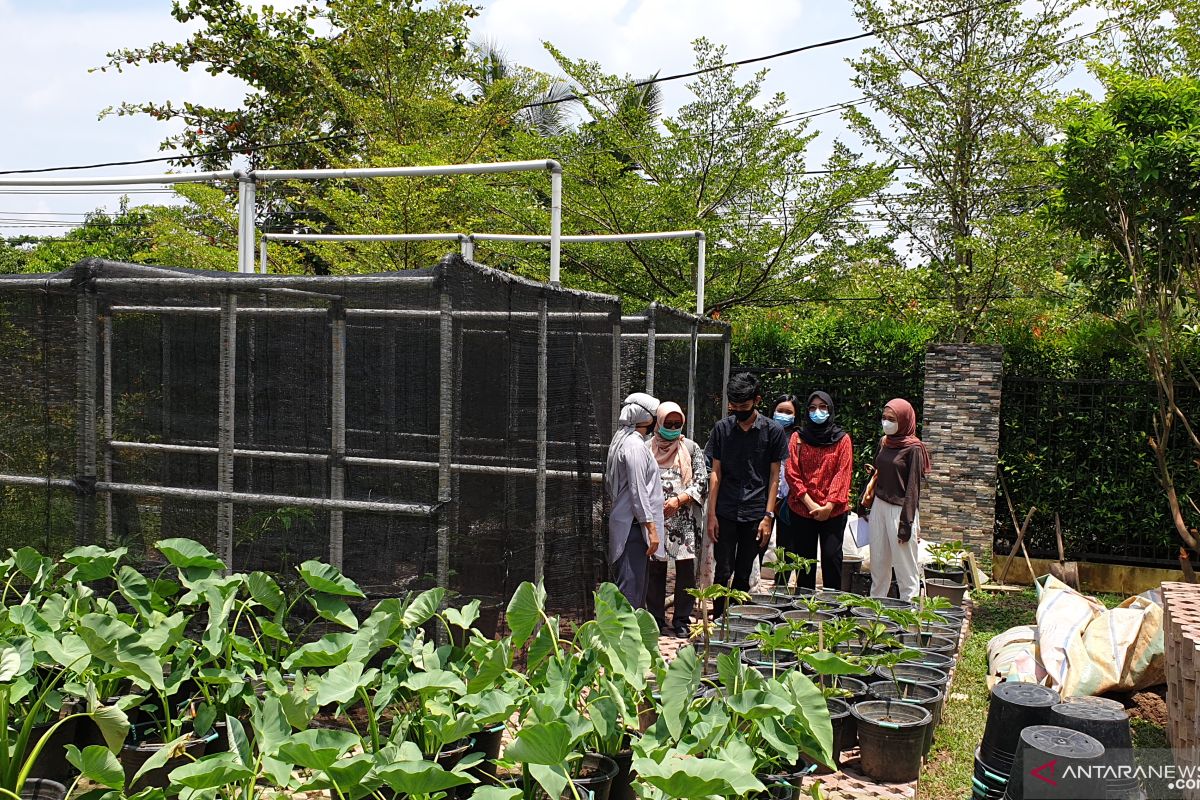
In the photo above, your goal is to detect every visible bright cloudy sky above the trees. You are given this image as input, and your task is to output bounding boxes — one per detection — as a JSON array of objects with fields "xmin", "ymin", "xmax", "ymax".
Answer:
[{"xmin": 0, "ymin": 0, "xmax": 1104, "ymax": 236}]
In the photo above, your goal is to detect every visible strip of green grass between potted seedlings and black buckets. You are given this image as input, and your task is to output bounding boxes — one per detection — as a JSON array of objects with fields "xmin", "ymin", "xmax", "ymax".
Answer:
[{"xmin": 917, "ymin": 588, "xmax": 1168, "ymax": 800}]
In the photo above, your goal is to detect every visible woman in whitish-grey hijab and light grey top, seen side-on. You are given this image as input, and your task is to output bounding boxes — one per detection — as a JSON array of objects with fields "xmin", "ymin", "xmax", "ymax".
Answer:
[{"xmin": 604, "ymin": 392, "xmax": 664, "ymax": 608}]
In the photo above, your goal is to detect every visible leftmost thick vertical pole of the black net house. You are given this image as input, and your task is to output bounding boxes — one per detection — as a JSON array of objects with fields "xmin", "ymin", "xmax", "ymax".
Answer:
[{"xmin": 74, "ymin": 287, "xmax": 98, "ymax": 546}]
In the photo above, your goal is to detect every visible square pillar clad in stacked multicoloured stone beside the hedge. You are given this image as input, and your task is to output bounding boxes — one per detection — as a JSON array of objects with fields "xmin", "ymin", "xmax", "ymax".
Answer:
[{"xmin": 920, "ymin": 344, "xmax": 1003, "ymax": 557}]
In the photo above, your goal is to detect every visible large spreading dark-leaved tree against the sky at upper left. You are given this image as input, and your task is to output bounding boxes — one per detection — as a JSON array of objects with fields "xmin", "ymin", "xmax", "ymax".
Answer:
[{"xmin": 98, "ymin": 0, "xmax": 476, "ymax": 169}]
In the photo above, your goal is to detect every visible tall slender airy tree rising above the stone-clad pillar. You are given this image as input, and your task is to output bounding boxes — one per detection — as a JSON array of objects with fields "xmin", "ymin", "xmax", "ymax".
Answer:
[{"xmin": 846, "ymin": 0, "xmax": 1080, "ymax": 342}]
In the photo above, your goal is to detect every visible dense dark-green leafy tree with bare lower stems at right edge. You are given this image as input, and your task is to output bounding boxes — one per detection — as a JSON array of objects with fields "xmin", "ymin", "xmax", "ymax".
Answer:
[{"xmin": 1050, "ymin": 71, "xmax": 1200, "ymax": 579}]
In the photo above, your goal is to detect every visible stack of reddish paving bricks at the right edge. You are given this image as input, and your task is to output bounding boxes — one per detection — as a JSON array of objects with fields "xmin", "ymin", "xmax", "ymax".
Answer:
[{"xmin": 1163, "ymin": 583, "xmax": 1200, "ymax": 800}]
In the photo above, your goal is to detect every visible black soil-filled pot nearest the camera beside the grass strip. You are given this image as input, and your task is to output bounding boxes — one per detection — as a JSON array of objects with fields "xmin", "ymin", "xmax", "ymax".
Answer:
[{"xmin": 851, "ymin": 700, "xmax": 932, "ymax": 783}]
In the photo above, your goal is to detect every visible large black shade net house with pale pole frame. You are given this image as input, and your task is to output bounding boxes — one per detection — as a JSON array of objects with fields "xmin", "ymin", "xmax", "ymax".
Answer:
[{"xmin": 0, "ymin": 255, "xmax": 728, "ymax": 616}]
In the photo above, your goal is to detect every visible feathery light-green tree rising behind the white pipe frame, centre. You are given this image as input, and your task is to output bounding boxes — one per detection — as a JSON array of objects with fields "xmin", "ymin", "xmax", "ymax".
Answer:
[{"xmin": 472, "ymin": 38, "xmax": 888, "ymax": 314}]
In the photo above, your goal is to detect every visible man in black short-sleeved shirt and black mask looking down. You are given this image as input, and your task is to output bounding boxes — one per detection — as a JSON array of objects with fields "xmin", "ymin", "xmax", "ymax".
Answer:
[{"xmin": 704, "ymin": 372, "xmax": 787, "ymax": 619}]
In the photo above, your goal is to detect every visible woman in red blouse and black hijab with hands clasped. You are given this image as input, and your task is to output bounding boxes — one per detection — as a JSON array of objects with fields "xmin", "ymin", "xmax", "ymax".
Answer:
[{"xmin": 779, "ymin": 392, "xmax": 854, "ymax": 590}]
